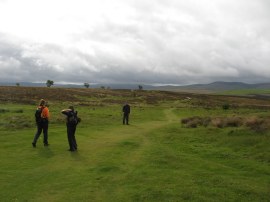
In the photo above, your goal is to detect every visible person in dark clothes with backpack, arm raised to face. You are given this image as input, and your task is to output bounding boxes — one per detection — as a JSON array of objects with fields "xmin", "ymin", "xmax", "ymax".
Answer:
[{"xmin": 61, "ymin": 106, "xmax": 80, "ymax": 151}]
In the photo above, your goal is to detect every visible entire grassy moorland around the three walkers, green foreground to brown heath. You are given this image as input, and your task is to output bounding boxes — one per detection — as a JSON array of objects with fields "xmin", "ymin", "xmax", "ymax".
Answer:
[{"xmin": 0, "ymin": 87, "xmax": 270, "ymax": 202}]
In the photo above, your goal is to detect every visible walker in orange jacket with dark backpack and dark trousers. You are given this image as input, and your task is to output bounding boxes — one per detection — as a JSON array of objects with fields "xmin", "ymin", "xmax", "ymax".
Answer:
[{"xmin": 32, "ymin": 99, "xmax": 50, "ymax": 147}]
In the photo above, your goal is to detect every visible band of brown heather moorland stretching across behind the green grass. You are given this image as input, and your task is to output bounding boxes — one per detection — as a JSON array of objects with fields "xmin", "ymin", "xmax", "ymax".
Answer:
[{"xmin": 0, "ymin": 86, "xmax": 270, "ymax": 109}]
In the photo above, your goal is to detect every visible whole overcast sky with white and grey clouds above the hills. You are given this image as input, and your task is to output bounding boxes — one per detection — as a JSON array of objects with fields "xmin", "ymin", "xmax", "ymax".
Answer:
[{"xmin": 0, "ymin": 0, "xmax": 270, "ymax": 85}]
